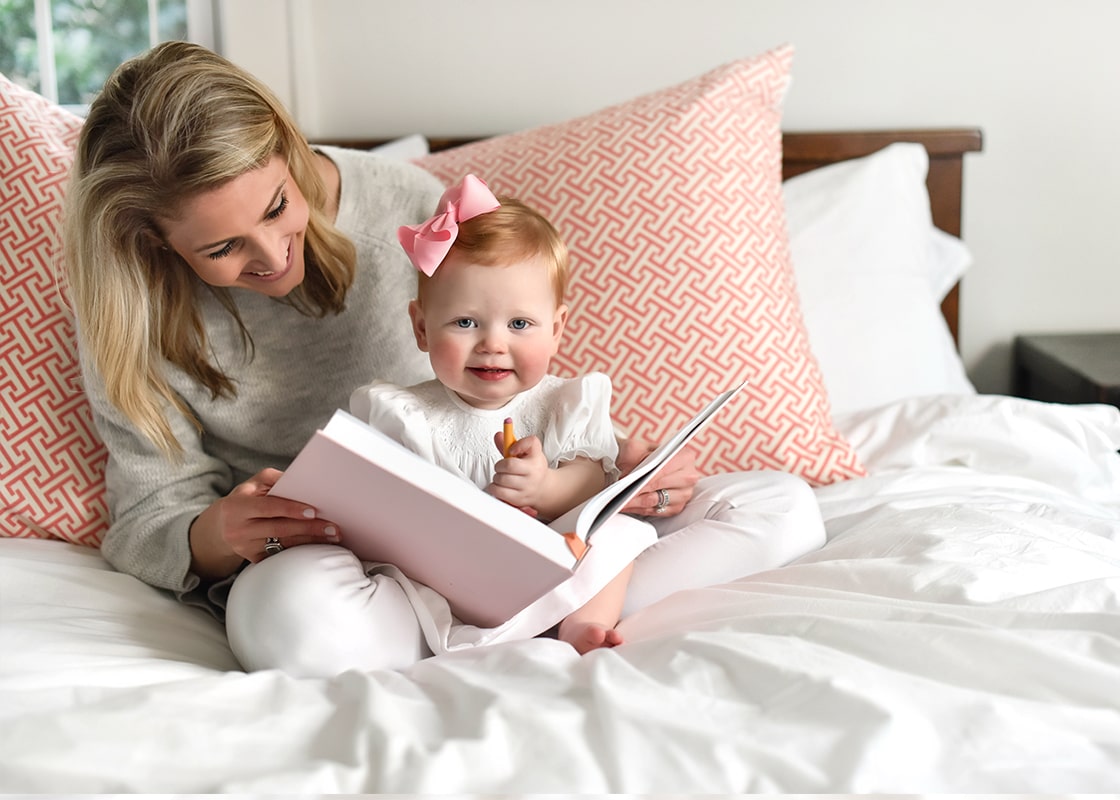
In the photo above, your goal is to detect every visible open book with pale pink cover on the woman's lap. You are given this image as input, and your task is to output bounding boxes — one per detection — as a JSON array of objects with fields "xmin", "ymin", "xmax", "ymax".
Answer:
[{"xmin": 270, "ymin": 382, "xmax": 746, "ymax": 627}]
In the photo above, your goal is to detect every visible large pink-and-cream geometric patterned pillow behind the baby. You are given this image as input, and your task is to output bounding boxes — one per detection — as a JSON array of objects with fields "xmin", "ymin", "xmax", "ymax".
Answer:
[{"xmin": 417, "ymin": 46, "xmax": 865, "ymax": 485}]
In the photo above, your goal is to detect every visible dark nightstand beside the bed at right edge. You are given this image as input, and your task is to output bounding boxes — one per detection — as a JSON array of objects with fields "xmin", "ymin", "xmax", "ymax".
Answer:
[{"xmin": 1014, "ymin": 333, "xmax": 1120, "ymax": 407}]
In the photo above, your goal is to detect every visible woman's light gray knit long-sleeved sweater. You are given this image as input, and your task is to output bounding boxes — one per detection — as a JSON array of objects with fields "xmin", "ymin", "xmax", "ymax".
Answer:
[{"xmin": 83, "ymin": 148, "xmax": 442, "ymax": 617}]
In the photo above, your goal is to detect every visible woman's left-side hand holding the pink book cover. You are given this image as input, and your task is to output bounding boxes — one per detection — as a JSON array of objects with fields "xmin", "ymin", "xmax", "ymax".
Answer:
[{"xmin": 190, "ymin": 469, "xmax": 338, "ymax": 580}]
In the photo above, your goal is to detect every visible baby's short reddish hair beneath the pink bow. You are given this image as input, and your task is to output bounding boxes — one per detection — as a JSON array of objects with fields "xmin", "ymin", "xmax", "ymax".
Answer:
[{"xmin": 417, "ymin": 197, "xmax": 570, "ymax": 305}]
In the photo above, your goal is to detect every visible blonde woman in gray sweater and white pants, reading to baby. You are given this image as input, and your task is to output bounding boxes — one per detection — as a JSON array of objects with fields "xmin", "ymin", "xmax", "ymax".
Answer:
[{"xmin": 64, "ymin": 43, "xmax": 721, "ymax": 675}]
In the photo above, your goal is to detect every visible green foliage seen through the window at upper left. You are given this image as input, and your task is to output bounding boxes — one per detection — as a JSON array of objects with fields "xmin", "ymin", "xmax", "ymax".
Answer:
[{"xmin": 0, "ymin": 0, "xmax": 187, "ymax": 105}]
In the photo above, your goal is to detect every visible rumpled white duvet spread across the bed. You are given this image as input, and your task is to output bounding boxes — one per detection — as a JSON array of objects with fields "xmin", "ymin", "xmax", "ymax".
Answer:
[{"xmin": 0, "ymin": 396, "xmax": 1120, "ymax": 793}]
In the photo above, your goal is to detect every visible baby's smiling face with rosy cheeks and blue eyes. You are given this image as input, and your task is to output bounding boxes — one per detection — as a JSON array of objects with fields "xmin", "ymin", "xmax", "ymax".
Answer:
[{"xmin": 409, "ymin": 253, "xmax": 568, "ymax": 409}]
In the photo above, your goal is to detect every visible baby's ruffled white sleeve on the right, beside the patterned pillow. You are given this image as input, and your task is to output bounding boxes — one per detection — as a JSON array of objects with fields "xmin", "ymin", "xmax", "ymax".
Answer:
[{"xmin": 541, "ymin": 372, "xmax": 618, "ymax": 482}]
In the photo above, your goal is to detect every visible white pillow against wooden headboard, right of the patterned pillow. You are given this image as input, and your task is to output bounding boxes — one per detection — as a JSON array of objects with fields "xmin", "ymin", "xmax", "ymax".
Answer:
[{"xmin": 783, "ymin": 143, "xmax": 976, "ymax": 413}]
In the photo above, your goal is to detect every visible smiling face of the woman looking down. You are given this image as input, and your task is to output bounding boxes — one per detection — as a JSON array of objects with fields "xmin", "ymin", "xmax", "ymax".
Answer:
[{"xmin": 160, "ymin": 156, "xmax": 308, "ymax": 297}]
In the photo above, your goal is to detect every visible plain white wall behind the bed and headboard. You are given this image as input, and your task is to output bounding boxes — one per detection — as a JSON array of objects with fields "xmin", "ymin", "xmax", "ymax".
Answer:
[{"xmin": 223, "ymin": 0, "xmax": 1120, "ymax": 391}]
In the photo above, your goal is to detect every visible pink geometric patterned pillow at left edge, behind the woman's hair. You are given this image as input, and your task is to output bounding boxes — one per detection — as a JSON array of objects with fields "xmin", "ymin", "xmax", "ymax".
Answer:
[{"xmin": 0, "ymin": 75, "xmax": 109, "ymax": 547}]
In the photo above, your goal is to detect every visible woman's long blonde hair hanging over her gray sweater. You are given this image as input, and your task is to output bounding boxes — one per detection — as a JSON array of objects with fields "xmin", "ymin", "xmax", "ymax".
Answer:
[{"xmin": 63, "ymin": 41, "xmax": 355, "ymax": 456}]
